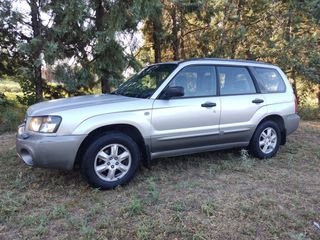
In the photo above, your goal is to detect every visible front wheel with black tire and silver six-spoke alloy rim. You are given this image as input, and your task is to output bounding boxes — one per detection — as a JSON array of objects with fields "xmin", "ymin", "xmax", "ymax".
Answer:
[{"xmin": 81, "ymin": 132, "xmax": 140, "ymax": 190}]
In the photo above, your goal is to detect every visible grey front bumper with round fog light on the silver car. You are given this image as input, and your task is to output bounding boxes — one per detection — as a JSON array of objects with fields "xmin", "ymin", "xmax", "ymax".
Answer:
[{"xmin": 16, "ymin": 130, "xmax": 86, "ymax": 170}]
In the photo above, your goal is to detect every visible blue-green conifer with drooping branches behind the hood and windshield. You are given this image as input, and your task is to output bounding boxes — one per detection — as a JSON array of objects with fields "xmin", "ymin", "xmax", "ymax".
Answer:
[{"xmin": 49, "ymin": 0, "xmax": 149, "ymax": 93}]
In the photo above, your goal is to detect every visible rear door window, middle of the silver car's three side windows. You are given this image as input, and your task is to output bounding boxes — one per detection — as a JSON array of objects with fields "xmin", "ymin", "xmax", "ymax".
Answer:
[{"xmin": 217, "ymin": 66, "xmax": 256, "ymax": 95}]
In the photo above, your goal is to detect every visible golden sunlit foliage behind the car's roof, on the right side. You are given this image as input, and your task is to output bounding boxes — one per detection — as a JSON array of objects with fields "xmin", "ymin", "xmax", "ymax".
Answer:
[{"xmin": 139, "ymin": 0, "xmax": 320, "ymax": 106}]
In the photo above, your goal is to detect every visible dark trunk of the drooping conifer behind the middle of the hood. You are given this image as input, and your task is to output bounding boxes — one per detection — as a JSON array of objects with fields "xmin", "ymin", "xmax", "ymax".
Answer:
[{"xmin": 96, "ymin": 0, "xmax": 110, "ymax": 93}]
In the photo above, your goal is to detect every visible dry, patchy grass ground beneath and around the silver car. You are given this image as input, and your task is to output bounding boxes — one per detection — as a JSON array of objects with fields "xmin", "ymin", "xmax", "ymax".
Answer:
[{"xmin": 0, "ymin": 122, "xmax": 320, "ymax": 239}]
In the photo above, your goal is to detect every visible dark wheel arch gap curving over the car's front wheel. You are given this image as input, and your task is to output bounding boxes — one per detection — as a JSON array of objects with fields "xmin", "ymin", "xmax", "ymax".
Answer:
[{"xmin": 74, "ymin": 124, "xmax": 151, "ymax": 167}]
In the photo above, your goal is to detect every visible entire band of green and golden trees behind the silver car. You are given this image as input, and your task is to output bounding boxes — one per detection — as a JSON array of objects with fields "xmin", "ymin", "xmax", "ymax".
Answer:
[{"xmin": 0, "ymin": 0, "xmax": 320, "ymax": 107}]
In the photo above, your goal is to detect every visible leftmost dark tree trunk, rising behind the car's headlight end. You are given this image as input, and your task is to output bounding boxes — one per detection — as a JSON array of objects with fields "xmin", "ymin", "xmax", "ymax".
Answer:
[{"xmin": 29, "ymin": 0, "xmax": 43, "ymax": 102}]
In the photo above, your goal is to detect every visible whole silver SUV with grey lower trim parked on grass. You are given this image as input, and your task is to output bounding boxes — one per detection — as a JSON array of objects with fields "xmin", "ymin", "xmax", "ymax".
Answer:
[{"xmin": 16, "ymin": 59, "xmax": 299, "ymax": 189}]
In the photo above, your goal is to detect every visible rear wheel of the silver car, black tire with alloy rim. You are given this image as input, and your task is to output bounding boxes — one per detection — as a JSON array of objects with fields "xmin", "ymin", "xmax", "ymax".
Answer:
[{"xmin": 249, "ymin": 121, "xmax": 281, "ymax": 159}]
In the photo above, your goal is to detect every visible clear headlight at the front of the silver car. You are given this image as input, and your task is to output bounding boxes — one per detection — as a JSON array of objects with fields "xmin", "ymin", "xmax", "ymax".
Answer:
[{"xmin": 28, "ymin": 116, "xmax": 61, "ymax": 133}]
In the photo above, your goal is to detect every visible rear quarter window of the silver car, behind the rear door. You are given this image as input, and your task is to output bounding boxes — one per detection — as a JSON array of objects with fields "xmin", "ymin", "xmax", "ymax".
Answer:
[{"xmin": 254, "ymin": 67, "xmax": 286, "ymax": 93}]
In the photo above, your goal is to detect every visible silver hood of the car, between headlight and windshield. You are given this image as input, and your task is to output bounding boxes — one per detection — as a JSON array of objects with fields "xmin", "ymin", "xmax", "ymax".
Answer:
[{"xmin": 27, "ymin": 94, "xmax": 141, "ymax": 116}]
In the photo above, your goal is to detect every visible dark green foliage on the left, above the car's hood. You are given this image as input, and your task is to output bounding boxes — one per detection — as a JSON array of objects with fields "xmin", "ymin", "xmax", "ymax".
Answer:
[{"xmin": 0, "ymin": 0, "xmax": 151, "ymax": 104}]
